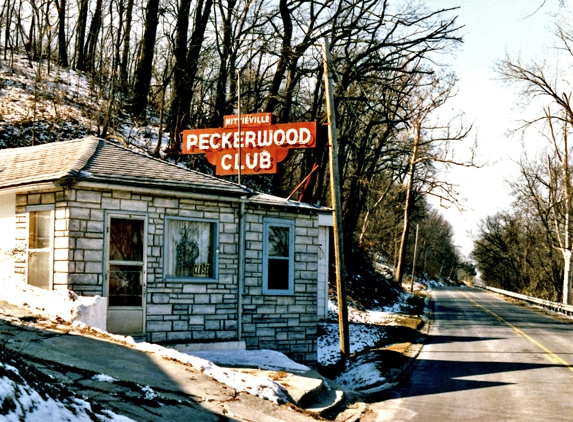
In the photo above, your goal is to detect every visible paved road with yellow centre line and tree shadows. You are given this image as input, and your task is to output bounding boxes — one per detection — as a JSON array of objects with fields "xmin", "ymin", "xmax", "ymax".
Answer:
[{"xmin": 361, "ymin": 288, "xmax": 573, "ymax": 422}]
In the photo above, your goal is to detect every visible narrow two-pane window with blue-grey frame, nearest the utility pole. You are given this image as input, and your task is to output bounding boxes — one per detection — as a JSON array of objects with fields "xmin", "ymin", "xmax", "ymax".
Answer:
[{"xmin": 263, "ymin": 219, "xmax": 294, "ymax": 294}]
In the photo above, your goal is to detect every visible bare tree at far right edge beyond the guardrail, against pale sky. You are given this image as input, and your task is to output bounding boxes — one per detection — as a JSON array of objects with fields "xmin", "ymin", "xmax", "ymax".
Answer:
[{"xmin": 497, "ymin": 19, "xmax": 573, "ymax": 304}]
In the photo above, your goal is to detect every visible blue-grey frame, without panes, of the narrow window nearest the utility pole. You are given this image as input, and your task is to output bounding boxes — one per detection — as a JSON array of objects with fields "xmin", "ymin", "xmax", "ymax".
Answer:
[{"xmin": 262, "ymin": 218, "xmax": 295, "ymax": 296}]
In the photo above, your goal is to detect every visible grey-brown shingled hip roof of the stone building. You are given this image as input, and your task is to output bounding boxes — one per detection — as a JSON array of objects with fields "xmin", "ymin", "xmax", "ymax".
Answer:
[{"xmin": 0, "ymin": 137, "xmax": 253, "ymax": 196}]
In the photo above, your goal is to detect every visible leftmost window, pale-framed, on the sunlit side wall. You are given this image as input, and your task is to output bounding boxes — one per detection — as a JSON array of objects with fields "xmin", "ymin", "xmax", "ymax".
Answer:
[{"xmin": 27, "ymin": 206, "xmax": 54, "ymax": 290}]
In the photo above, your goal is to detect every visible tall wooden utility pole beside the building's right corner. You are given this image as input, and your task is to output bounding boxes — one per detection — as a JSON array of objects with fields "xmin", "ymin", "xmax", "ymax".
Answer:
[{"xmin": 322, "ymin": 37, "xmax": 350, "ymax": 360}]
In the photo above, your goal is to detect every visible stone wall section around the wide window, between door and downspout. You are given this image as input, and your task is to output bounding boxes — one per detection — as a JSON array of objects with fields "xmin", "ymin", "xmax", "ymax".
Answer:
[{"xmin": 147, "ymin": 197, "xmax": 239, "ymax": 342}]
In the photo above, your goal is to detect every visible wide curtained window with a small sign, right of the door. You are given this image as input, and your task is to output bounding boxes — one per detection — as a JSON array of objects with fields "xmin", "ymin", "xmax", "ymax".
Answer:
[{"xmin": 165, "ymin": 218, "xmax": 217, "ymax": 279}]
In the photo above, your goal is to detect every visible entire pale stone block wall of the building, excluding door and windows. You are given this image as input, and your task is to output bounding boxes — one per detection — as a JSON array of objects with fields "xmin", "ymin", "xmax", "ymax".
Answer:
[{"xmin": 16, "ymin": 189, "xmax": 319, "ymax": 365}]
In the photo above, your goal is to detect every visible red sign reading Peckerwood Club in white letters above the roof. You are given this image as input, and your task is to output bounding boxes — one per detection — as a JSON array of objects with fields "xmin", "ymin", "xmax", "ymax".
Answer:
[{"xmin": 182, "ymin": 113, "xmax": 316, "ymax": 175}]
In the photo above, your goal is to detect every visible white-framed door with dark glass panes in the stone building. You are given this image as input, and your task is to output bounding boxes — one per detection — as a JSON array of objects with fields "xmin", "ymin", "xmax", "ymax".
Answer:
[{"xmin": 105, "ymin": 214, "xmax": 147, "ymax": 335}]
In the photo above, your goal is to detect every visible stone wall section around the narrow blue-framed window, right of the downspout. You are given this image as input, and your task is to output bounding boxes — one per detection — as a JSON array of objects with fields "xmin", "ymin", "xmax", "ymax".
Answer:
[{"xmin": 243, "ymin": 209, "xmax": 319, "ymax": 365}]
